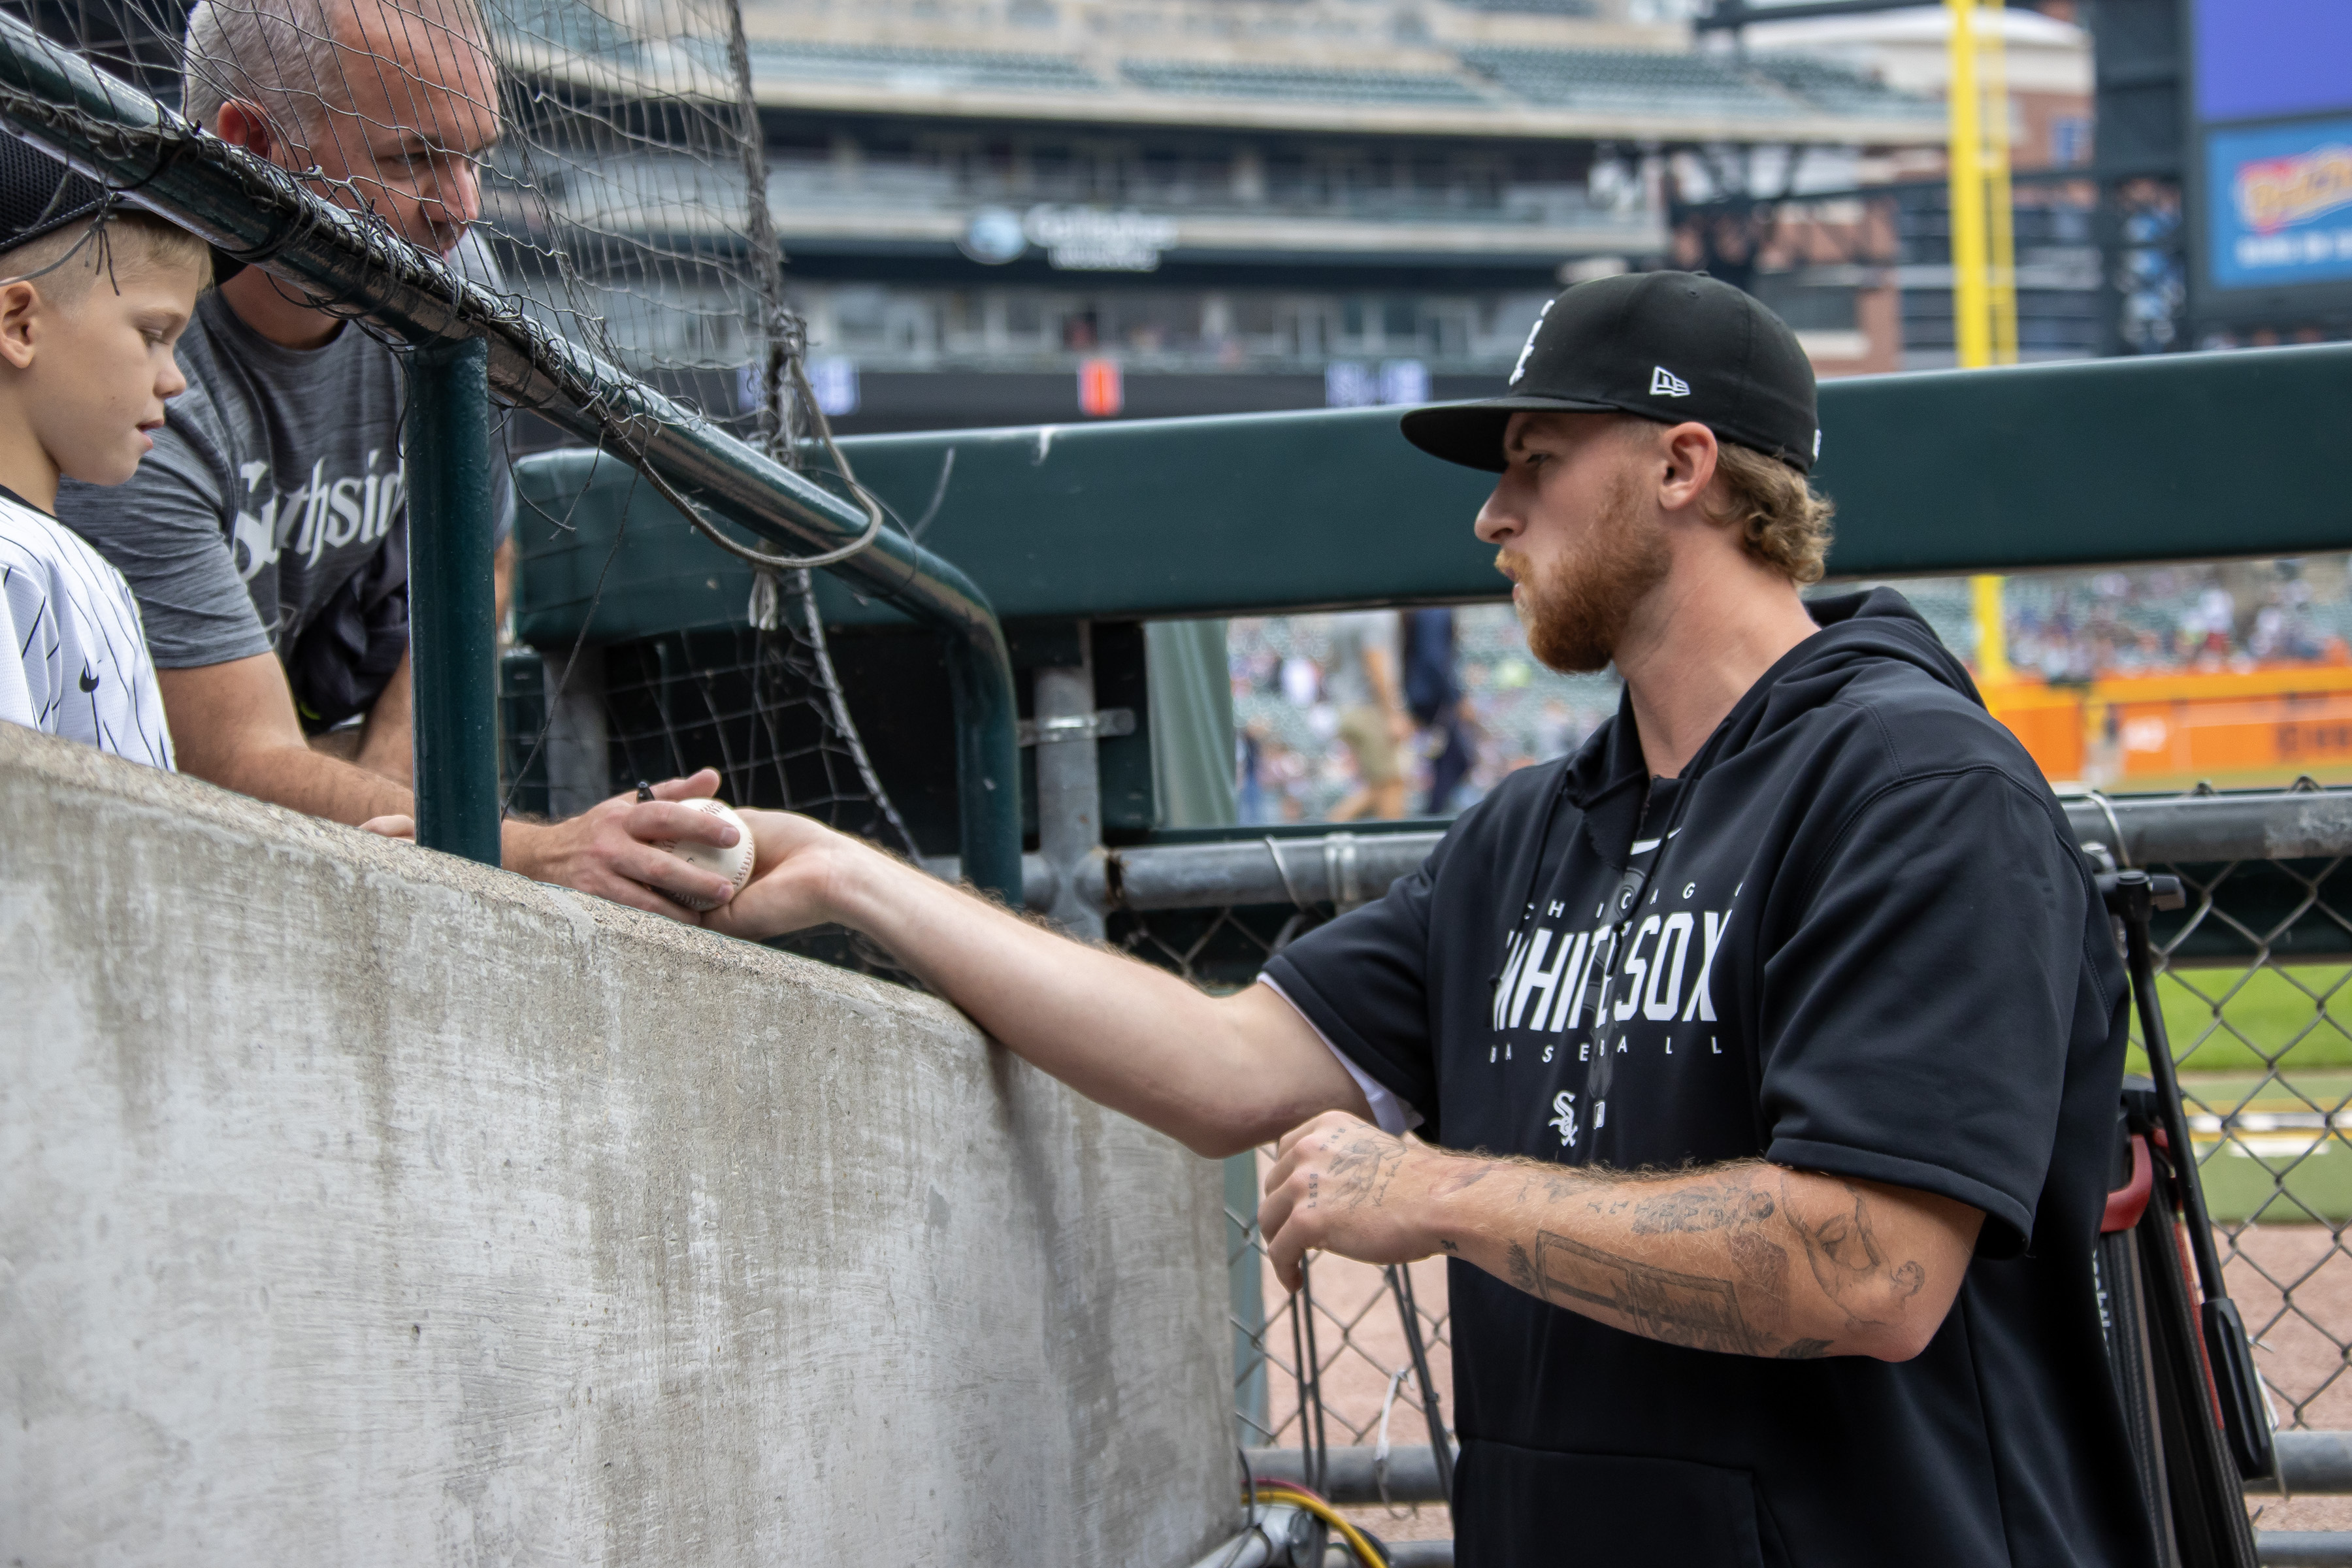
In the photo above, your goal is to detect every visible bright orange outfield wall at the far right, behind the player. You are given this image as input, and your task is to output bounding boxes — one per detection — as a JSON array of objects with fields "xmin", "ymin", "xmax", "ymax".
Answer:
[{"xmin": 1985, "ymin": 665, "xmax": 2352, "ymax": 787}]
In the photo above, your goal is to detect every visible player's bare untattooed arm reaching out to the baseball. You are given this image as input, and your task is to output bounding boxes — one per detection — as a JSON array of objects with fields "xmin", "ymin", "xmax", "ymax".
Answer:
[{"xmin": 703, "ymin": 811, "xmax": 1369, "ymax": 1156}]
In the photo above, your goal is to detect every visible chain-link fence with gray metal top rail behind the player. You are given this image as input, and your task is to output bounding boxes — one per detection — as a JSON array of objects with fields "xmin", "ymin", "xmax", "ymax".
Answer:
[{"xmin": 1108, "ymin": 781, "xmax": 2352, "ymax": 1561}]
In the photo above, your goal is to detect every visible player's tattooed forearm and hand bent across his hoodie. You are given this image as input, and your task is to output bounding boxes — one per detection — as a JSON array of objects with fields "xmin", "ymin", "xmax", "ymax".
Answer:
[{"xmin": 1258, "ymin": 1115, "xmax": 1985, "ymax": 1361}]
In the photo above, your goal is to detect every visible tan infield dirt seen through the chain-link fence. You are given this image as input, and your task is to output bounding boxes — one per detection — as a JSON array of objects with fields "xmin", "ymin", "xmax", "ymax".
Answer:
[{"xmin": 1266, "ymin": 1225, "xmax": 2352, "ymax": 1540}]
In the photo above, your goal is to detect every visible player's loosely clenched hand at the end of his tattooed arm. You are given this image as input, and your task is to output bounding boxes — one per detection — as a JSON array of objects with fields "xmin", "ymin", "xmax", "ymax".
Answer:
[{"xmin": 1258, "ymin": 1109, "xmax": 1473, "ymax": 1290}]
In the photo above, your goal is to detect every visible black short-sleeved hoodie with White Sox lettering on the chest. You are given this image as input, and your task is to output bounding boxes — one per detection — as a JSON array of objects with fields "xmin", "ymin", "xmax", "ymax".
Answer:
[{"xmin": 1266, "ymin": 590, "xmax": 2155, "ymax": 1568}]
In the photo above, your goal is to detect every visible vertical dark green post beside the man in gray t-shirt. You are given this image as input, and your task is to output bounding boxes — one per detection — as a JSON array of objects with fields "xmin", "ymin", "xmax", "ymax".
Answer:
[{"xmin": 402, "ymin": 338, "xmax": 498, "ymax": 865}]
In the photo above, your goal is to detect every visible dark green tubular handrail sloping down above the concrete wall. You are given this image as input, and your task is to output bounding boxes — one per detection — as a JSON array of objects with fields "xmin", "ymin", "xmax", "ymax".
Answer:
[{"xmin": 0, "ymin": 14, "xmax": 1021, "ymax": 903}]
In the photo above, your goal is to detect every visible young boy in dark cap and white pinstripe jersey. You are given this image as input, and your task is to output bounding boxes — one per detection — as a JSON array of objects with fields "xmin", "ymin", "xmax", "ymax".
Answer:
[{"xmin": 0, "ymin": 141, "xmax": 212, "ymax": 769}]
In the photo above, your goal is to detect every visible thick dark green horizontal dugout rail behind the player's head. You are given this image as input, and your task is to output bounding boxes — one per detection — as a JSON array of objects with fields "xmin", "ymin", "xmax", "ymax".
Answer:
[{"xmin": 500, "ymin": 343, "xmax": 2352, "ymax": 637}]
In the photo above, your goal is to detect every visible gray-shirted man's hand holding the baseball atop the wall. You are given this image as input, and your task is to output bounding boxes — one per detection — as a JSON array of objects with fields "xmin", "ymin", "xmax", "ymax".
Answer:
[{"xmin": 506, "ymin": 769, "xmax": 736, "ymax": 926}]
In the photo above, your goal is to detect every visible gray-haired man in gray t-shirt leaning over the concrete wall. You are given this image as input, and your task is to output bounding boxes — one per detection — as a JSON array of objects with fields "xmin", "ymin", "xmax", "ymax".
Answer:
[{"xmin": 59, "ymin": 0, "xmax": 734, "ymax": 921}]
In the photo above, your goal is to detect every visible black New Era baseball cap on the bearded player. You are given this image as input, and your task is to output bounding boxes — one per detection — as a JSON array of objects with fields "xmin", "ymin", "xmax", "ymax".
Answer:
[{"xmin": 1404, "ymin": 272, "xmax": 1820, "ymax": 472}]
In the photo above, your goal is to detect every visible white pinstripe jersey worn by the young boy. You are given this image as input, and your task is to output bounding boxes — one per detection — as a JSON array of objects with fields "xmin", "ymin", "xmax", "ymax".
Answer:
[{"xmin": 0, "ymin": 489, "xmax": 172, "ymax": 769}]
